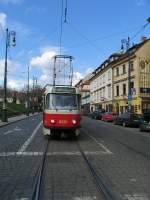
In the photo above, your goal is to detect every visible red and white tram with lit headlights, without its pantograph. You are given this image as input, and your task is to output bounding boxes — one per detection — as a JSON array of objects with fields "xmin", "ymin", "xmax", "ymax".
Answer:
[{"xmin": 43, "ymin": 85, "xmax": 81, "ymax": 136}]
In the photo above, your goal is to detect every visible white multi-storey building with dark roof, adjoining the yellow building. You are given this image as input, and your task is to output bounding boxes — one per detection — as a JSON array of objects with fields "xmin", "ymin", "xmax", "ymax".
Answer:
[{"xmin": 90, "ymin": 54, "xmax": 119, "ymax": 112}]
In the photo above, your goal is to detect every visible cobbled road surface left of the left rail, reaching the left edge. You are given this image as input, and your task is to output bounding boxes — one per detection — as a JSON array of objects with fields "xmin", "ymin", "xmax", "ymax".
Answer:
[{"xmin": 0, "ymin": 115, "xmax": 44, "ymax": 200}]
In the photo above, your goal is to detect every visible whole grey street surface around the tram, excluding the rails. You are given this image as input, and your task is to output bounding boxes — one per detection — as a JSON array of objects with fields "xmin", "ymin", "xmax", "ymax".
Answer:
[{"xmin": 0, "ymin": 115, "xmax": 150, "ymax": 200}]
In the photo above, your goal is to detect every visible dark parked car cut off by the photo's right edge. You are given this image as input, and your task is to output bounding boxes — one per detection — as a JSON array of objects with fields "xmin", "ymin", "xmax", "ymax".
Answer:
[{"xmin": 140, "ymin": 113, "xmax": 150, "ymax": 131}]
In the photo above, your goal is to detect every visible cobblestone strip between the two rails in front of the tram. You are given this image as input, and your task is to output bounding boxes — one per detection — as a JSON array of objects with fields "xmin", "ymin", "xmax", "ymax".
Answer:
[{"xmin": 40, "ymin": 140, "xmax": 104, "ymax": 200}]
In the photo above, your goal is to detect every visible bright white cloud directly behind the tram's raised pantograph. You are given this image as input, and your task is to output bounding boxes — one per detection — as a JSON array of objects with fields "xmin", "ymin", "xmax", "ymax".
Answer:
[{"xmin": 30, "ymin": 46, "xmax": 93, "ymax": 85}]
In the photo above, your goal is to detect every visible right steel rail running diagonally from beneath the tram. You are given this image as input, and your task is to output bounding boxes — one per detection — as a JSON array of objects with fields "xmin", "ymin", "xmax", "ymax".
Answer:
[{"xmin": 77, "ymin": 142, "xmax": 122, "ymax": 200}]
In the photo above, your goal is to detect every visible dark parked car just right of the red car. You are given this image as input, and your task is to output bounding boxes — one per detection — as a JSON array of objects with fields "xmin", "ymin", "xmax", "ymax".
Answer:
[{"xmin": 114, "ymin": 112, "xmax": 141, "ymax": 127}]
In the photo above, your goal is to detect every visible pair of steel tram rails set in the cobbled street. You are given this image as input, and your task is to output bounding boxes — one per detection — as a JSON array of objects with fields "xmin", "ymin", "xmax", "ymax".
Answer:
[{"xmin": 30, "ymin": 136, "xmax": 121, "ymax": 200}]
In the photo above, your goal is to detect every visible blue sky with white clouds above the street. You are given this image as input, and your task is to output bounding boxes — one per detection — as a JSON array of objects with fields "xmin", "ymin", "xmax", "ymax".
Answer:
[{"xmin": 0, "ymin": 0, "xmax": 150, "ymax": 88}]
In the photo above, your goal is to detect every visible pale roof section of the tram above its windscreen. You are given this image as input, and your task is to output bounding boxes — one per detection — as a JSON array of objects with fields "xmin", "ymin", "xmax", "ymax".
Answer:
[{"xmin": 44, "ymin": 85, "xmax": 80, "ymax": 94}]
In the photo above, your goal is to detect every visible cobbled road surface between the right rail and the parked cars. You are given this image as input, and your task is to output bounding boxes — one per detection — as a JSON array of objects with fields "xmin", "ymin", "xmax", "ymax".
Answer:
[{"xmin": 82, "ymin": 117, "xmax": 150, "ymax": 200}]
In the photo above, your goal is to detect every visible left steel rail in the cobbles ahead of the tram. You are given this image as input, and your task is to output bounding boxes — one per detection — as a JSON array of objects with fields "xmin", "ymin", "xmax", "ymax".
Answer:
[{"xmin": 30, "ymin": 140, "xmax": 49, "ymax": 200}]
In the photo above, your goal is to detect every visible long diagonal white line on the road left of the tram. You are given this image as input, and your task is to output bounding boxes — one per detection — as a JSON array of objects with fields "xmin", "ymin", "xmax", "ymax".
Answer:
[{"xmin": 17, "ymin": 121, "xmax": 42, "ymax": 153}]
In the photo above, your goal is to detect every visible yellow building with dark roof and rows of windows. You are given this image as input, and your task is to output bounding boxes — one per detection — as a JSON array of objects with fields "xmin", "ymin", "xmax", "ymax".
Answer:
[{"xmin": 112, "ymin": 39, "xmax": 150, "ymax": 114}]
